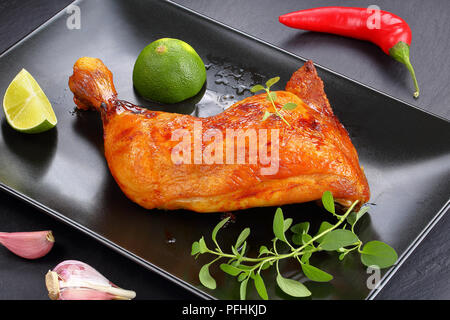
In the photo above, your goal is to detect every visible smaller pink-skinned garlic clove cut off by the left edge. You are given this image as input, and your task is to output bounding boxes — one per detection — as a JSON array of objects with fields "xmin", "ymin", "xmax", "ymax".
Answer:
[{"xmin": 0, "ymin": 231, "xmax": 55, "ymax": 259}]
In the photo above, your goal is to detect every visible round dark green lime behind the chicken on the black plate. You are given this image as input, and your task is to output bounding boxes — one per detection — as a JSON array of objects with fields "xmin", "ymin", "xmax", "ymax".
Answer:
[{"xmin": 133, "ymin": 38, "xmax": 206, "ymax": 103}]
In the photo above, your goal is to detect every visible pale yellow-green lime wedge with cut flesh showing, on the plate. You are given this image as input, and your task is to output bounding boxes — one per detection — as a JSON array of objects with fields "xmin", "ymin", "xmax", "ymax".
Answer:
[{"xmin": 3, "ymin": 69, "xmax": 58, "ymax": 133}]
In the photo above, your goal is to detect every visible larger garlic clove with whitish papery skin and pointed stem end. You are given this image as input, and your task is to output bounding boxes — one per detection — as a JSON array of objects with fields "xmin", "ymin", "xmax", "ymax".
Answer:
[{"xmin": 45, "ymin": 260, "xmax": 136, "ymax": 300}]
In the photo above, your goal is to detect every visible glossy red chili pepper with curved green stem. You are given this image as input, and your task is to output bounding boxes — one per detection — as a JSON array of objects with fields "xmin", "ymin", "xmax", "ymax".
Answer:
[{"xmin": 279, "ymin": 7, "xmax": 419, "ymax": 98}]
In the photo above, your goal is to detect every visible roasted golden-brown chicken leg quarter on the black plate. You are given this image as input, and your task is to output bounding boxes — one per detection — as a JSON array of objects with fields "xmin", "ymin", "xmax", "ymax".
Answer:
[{"xmin": 69, "ymin": 57, "xmax": 370, "ymax": 212}]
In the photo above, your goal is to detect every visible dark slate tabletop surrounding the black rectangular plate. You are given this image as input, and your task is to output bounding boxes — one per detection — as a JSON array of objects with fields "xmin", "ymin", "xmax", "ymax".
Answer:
[{"xmin": 0, "ymin": 0, "xmax": 450, "ymax": 299}]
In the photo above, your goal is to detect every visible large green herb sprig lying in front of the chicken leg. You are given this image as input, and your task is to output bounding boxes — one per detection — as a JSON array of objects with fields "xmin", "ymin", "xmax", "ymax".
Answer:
[{"xmin": 191, "ymin": 191, "xmax": 398, "ymax": 300}]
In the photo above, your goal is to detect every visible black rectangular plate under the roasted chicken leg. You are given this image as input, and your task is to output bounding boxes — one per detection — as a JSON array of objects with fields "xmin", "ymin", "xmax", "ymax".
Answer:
[{"xmin": 0, "ymin": 0, "xmax": 450, "ymax": 299}]
